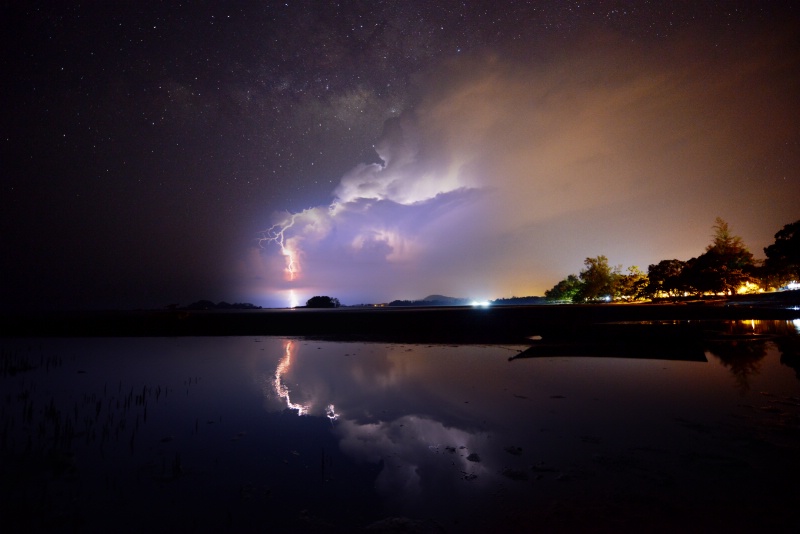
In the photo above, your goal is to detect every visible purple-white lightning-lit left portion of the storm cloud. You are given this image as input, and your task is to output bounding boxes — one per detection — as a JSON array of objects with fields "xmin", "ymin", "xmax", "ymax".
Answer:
[{"xmin": 259, "ymin": 111, "xmax": 488, "ymax": 306}]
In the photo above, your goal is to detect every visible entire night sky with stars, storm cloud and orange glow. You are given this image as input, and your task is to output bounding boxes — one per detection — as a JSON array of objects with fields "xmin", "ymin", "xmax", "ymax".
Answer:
[{"xmin": 0, "ymin": 0, "xmax": 800, "ymax": 309}]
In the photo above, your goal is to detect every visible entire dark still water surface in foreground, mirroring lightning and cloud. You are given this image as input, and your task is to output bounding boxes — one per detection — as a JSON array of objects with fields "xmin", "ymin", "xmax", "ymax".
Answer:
[{"xmin": 0, "ymin": 321, "xmax": 800, "ymax": 532}]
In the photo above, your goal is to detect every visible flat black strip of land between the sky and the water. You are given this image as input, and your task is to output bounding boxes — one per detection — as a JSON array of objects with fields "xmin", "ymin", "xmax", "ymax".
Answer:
[{"xmin": 0, "ymin": 291, "xmax": 800, "ymax": 343}]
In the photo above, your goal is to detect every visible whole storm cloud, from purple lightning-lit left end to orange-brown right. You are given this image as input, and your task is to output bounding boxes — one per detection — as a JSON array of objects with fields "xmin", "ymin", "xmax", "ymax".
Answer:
[{"xmin": 256, "ymin": 33, "xmax": 798, "ymax": 304}]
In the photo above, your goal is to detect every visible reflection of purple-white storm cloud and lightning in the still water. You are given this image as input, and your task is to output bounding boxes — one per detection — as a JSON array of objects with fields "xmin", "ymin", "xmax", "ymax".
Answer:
[{"xmin": 252, "ymin": 340, "xmax": 507, "ymax": 512}]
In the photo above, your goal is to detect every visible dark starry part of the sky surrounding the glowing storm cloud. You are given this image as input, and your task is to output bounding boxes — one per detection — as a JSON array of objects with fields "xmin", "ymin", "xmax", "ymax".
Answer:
[{"xmin": 0, "ymin": 0, "xmax": 798, "ymax": 308}]
